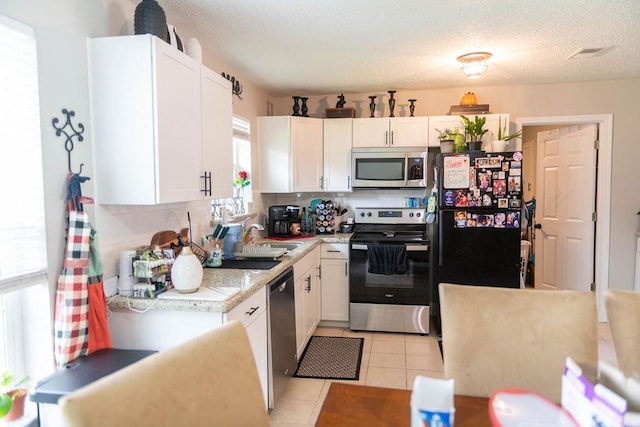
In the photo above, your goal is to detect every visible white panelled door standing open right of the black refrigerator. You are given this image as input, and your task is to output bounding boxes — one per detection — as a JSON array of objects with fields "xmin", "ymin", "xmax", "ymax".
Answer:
[{"xmin": 535, "ymin": 124, "xmax": 597, "ymax": 290}]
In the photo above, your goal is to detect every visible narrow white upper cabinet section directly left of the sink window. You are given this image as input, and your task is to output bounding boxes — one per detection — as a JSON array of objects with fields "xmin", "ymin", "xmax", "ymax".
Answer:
[{"xmin": 201, "ymin": 67, "xmax": 233, "ymax": 199}]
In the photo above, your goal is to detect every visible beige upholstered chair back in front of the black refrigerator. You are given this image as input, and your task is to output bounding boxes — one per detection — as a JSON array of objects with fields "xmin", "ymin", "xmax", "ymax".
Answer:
[{"xmin": 439, "ymin": 283, "xmax": 598, "ymax": 402}]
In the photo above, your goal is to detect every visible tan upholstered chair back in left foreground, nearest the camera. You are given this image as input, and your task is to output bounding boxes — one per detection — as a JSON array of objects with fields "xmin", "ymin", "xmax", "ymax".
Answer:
[{"xmin": 59, "ymin": 321, "xmax": 269, "ymax": 427}]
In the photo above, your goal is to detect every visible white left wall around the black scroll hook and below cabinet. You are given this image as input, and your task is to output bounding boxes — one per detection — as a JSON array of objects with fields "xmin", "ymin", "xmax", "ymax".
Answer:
[{"xmin": 0, "ymin": 0, "xmax": 267, "ymax": 294}]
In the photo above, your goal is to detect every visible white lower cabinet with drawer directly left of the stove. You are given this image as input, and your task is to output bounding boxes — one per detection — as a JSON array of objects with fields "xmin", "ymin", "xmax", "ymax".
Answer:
[{"xmin": 320, "ymin": 243, "xmax": 349, "ymax": 322}]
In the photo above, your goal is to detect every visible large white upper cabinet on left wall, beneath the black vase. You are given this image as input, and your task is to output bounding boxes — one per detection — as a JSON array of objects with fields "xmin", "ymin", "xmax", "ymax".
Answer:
[{"xmin": 89, "ymin": 35, "xmax": 233, "ymax": 205}]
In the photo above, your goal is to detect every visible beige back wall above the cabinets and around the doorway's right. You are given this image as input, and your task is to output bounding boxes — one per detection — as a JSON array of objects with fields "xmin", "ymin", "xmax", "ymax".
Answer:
[{"xmin": 274, "ymin": 79, "xmax": 640, "ymax": 289}]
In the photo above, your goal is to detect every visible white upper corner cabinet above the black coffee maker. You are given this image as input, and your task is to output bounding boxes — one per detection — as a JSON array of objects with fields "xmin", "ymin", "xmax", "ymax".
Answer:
[{"xmin": 258, "ymin": 116, "xmax": 323, "ymax": 193}]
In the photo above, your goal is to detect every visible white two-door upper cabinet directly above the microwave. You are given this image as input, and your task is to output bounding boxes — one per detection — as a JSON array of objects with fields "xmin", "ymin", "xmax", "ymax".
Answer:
[{"xmin": 353, "ymin": 116, "xmax": 429, "ymax": 147}]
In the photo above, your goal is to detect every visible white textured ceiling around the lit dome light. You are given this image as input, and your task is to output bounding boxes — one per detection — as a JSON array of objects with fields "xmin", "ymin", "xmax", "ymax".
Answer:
[{"xmin": 154, "ymin": 0, "xmax": 640, "ymax": 95}]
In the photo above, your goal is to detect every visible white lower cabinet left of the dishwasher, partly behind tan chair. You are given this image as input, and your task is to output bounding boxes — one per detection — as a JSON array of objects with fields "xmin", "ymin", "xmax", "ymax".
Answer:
[{"xmin": 225, "ymin": 287, "xmax": 269, "ymax": 407}]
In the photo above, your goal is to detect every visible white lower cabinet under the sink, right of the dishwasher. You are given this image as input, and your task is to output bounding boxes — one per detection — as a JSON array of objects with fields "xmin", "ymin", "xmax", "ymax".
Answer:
[{"xmin": 293, "ymin": 247, "xmax": 320, "ymax": 360}]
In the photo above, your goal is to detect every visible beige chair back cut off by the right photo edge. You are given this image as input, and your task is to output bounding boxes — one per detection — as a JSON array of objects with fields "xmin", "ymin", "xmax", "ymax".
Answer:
[{"xmin": 604, "ymin": 289, "xmax": 640, "ymax": 377}]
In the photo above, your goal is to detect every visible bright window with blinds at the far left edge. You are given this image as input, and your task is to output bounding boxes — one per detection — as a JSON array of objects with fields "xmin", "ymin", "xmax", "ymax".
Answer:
[{"xmin": 0, "ymin": 15, "xmax": 53, "ymax": 402}]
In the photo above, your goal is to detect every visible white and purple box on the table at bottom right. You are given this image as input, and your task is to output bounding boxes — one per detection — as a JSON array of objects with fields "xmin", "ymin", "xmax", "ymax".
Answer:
[{"xmin": 561, "ymin": 358, "xmax": 627, "ymax": 427}]
